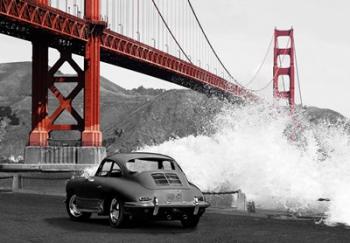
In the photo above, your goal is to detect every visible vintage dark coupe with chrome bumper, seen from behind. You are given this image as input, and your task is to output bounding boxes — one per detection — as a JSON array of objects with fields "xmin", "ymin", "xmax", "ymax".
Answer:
[{"xmin": 65, "ymin": 153, "xmax": 209, "ymax": 228}]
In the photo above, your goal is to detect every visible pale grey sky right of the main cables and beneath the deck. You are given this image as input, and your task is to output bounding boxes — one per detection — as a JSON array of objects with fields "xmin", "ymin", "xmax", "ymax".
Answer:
[{"xmin": 0, "ymin": 0, "xmax": 350, "ymax": 117}]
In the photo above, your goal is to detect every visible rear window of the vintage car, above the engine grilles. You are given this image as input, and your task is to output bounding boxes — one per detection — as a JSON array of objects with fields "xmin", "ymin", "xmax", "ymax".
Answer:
[{"xmin": 126, "ymin": 158, "xmax": 175, "ymax": 173}]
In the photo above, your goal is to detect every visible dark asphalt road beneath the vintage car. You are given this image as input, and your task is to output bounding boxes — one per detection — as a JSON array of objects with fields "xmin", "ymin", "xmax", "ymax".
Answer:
[{"xmin": 0, "ymin": 193, "xmax": 350, "ymax": 243}]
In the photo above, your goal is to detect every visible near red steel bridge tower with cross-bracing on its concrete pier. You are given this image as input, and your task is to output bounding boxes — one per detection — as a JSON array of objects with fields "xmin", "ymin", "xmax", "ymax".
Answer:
[{"xmin": 25, "ymin": 0, "xmax": 106, "ymax": 164}]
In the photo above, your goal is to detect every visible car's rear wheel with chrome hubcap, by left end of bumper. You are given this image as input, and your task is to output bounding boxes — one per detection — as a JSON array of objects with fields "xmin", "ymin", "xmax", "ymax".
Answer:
[{"xmin": 108, "ymin": 197, "xmax": 126, "ymax": 228}]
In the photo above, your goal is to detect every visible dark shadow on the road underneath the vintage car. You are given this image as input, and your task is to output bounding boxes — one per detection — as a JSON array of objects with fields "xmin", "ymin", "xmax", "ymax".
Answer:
[{"xmin": 45, "ymin": 217, "xmax": 195, "ymax": 234}]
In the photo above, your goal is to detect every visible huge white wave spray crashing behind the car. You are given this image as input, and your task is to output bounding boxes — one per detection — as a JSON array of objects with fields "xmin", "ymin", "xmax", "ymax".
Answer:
[{"xmin": 141, "ymin": 102, "xmax": 350, "ymax": 225}]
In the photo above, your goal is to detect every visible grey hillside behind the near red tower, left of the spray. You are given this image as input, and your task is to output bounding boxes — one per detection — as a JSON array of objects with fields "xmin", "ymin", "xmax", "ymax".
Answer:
[{"xmin": 0, "ymin": 62, "xmax": 221, "ymax": 157}]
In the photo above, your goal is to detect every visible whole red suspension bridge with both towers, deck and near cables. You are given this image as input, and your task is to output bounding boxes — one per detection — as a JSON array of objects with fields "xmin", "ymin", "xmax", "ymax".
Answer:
[{"xmin": 0, "ymin": 0, "xmax": 295, "ymax": 164}]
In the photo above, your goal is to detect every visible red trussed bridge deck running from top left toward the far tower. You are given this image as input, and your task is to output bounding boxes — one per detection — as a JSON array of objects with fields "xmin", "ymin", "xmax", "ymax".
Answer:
[{"xmin": 0, "ymin": 0, "xmax": 259, "ymax": 101}]
